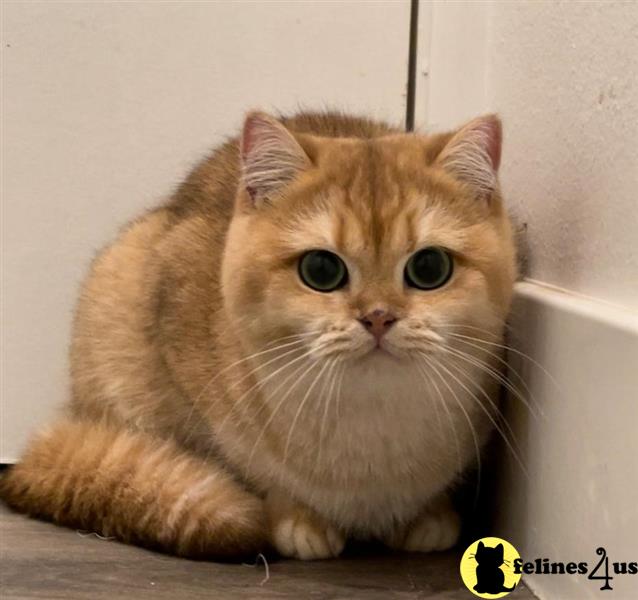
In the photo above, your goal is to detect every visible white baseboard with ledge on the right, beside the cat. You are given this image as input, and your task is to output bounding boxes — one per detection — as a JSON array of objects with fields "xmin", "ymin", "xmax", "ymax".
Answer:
[{"xmin": 494, "ymin": 282, "xmax": 638, "ymax": 600}]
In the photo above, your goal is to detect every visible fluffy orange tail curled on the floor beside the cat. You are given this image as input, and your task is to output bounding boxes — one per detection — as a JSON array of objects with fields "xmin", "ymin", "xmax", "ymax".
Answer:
[{"xmin": 0, "ymin": 422, "xmax": 266, "ymax": 560}]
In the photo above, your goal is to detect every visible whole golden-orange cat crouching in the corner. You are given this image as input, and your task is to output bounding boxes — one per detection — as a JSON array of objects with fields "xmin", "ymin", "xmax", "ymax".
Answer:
[{"xmin": 2, "ymin": 114, "xmax": 515, "ymax": 558}]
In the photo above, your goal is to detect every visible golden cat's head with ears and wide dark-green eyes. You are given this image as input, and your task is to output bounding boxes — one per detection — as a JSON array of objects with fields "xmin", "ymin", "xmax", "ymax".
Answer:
[{"xmin": 223, "ymin": 112, "xmax": 516, "ymax": 362}]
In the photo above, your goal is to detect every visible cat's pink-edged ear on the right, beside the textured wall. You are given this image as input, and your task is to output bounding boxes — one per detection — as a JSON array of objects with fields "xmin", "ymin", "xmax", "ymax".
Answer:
[{"xmin": 435, "ymin": 115, "xmax": 503, "ymax": 199}]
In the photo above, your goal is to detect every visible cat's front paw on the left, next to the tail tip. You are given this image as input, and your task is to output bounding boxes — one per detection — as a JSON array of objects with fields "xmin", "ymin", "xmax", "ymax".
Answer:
[{"xmin": 272, "ymin": 514, "xmax": 345, "ymax": 560}]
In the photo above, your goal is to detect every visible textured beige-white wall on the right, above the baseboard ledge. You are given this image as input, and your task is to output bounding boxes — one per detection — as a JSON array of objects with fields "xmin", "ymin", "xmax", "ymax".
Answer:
[{"xmin": 486, "ymin": 2, "xmax": 638, "ymax": 310}]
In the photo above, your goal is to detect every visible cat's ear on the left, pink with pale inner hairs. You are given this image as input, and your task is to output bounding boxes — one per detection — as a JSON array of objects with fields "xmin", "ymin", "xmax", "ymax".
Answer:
[{"xmin": 239, "ymin": 112, "xmax": 311, "ymax": 206}]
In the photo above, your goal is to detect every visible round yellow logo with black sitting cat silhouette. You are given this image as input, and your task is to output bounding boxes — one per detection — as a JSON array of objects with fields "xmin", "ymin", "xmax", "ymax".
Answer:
[{"xmin": 461, "ymin": 538, "xmax": 521, "ymax": 598}]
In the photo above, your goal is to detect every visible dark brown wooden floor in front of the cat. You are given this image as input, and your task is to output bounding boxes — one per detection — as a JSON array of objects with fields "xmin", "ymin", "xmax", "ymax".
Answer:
[{"xmin": 0, "ymin": 505, "xmax": 534, "ymax": 600}]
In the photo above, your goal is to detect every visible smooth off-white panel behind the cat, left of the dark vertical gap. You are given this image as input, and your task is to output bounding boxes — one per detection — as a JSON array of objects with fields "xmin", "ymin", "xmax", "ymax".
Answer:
[{"xmin": 0, "ymin": 0, "xmax": 409, "ymax": 461}]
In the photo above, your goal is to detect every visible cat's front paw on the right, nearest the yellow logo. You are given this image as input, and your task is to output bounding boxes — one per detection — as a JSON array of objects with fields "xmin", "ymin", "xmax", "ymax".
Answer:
[{"xmin": 386, "ymin": 496, "xmax": 461, "ymax": 552}]
